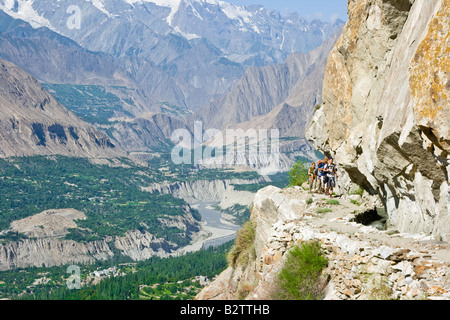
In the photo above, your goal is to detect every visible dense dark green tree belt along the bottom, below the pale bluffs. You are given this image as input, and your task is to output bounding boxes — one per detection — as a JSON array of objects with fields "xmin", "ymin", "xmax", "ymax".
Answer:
[{"xmin": 13, "ymin": 242, "xmax": 232, "ymax": 300}]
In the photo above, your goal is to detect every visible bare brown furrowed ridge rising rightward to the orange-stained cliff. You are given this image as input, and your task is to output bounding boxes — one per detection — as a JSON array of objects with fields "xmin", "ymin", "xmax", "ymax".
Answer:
[{"xmin": 198, "ymin": 30, "xmax": 341, "ymax": 129}]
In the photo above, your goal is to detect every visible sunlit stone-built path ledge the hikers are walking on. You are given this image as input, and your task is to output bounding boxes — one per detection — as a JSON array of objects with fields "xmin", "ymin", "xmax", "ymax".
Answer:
[{"xmin": 196, "ymin": 186, "xmax": 450, "ymax": 300}]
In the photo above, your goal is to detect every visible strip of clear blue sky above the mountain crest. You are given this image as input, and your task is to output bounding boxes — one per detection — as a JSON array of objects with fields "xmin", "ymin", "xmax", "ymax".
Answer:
[{"xmin": 226, "ymin": 0, "xmax": 347, "ymax": 22}]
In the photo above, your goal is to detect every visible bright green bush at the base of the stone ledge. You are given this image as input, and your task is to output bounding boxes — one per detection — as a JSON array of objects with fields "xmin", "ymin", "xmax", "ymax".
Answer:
[{"xmin": 272, "ymin": 241, "xmax": 328, "ymax": 300}]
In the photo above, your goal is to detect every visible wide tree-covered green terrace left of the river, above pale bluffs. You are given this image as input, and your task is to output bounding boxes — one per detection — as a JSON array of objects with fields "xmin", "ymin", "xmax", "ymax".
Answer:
[{"xmin": 0, "ymin": 157, "xmax": 193, "ymax": 245}]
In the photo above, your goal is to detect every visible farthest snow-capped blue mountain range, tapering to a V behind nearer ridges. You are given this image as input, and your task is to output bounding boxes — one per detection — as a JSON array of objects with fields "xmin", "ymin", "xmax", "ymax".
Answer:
[{"xmin": 0, "ymin": 0, "xmax": 342, "ymax": 110}]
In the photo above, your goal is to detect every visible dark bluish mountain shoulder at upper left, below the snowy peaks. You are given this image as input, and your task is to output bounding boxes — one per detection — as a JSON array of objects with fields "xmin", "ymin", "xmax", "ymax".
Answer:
[{"xmin": 0, "ymin": 10, "xmax": 137, "ymax": 87}]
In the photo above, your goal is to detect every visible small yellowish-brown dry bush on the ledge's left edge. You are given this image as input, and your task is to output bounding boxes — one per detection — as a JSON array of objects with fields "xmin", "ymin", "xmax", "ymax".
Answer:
[{"xmin": 227, "ymin": 221, "xmax": 256, "ymax": 268}]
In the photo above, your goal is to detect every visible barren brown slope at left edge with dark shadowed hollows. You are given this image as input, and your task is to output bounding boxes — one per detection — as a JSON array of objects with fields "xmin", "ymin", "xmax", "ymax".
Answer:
[{"xmin": 0, "ymin": 59, "xmax": 125, "ymax": 158}]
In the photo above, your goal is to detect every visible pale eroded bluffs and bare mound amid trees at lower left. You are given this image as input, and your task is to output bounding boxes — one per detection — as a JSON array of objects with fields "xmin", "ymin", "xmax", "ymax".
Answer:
[{"xmin": 0, "ymin": 206, "xmax": 200, "ymax": 271}]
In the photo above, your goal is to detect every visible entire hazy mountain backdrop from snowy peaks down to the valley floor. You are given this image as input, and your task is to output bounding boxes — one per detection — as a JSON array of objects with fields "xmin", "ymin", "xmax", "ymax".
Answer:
[{"xmin": 0, "ymin": 0, "xmax": 343, "ymax": 168}]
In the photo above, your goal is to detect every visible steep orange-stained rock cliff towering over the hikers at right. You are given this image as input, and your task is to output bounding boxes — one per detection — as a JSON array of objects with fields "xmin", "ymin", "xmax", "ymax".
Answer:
[{"xmin": 307, "ymin": 0, "xmax": 450, "ymax": 241}]
